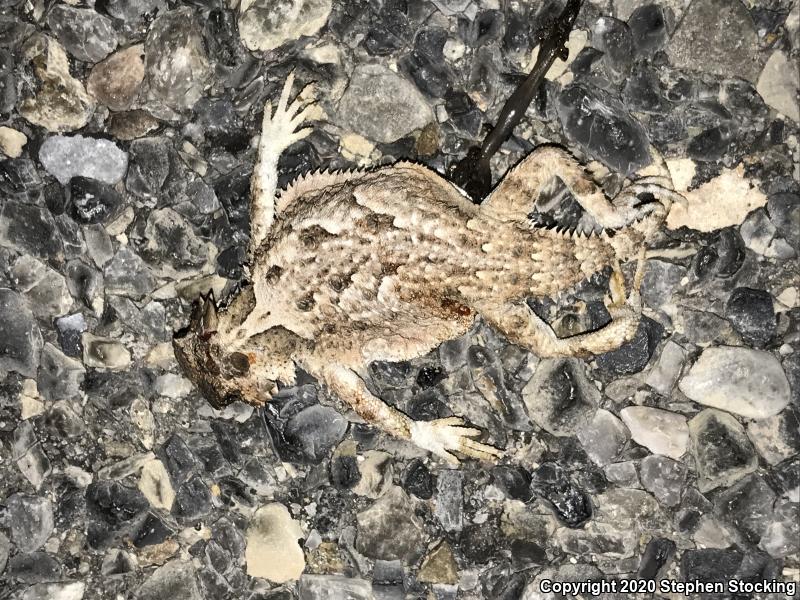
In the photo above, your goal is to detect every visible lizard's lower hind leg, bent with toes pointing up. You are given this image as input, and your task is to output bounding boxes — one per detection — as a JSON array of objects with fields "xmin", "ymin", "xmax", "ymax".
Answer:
[{"xmin": 479, "ymin": 252, "xmax": 644, "ymax": 357}]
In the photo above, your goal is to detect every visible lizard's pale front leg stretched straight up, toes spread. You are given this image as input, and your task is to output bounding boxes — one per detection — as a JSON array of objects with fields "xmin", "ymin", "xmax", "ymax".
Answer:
[{"xmin": 250, "ymin": 73, "xmax": 311, "ymax": 255}]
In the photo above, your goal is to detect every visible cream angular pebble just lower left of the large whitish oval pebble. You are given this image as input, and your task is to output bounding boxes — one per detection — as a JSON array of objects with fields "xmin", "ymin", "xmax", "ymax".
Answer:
[{"xmin": 619, "ymin": 406, "xmax": 689, "ymax": 459}]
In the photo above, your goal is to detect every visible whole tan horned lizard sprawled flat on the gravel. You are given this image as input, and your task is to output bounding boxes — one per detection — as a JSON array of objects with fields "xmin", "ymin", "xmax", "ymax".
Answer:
[{"xmin": 174, "ymin": 75, "xmax": 677, "ymax": 464}]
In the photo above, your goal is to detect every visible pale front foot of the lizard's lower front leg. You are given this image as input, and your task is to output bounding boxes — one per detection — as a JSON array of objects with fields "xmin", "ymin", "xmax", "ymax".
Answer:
[{"xmin": 410, "ymin": 417, "xmax": 503, "ymax": 466}]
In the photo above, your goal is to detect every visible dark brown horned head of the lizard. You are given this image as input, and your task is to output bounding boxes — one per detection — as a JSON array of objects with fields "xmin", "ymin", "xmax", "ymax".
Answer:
[{"xmin": 172, "ymin": 293, "xmax": 276, "ymax": 409}]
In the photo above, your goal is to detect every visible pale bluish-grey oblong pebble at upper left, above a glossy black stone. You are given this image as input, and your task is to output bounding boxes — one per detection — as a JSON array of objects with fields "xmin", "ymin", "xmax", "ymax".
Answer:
[{"xmin": 39, "ymin": 135, "xmax": 128, "ymax": 185}]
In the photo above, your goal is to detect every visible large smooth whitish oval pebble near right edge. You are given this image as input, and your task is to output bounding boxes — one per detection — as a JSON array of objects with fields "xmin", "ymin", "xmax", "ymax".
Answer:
[{"xmin": 678, "ymin": 346, "xmax": 791, "ymax": 419}]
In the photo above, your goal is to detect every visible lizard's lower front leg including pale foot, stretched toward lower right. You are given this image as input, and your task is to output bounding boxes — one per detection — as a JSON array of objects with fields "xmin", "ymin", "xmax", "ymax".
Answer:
[{"xmin": 319, "ymin": 365, "xmax": 503, "ymax": 465}]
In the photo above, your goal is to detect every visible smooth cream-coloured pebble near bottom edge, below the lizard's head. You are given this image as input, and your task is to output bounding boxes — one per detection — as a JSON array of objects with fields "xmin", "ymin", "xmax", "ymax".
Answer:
[{"xmin": 245, "ymin": 502, "xmax": 306, "ymax": 583}]
